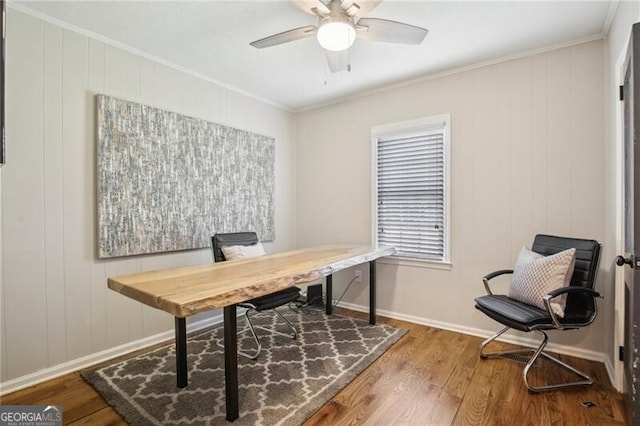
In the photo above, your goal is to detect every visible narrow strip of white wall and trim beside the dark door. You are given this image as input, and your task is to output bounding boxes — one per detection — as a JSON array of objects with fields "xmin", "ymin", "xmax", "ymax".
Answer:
[{"xmin": 603, "ymin": 1, "xmax": 640, "ymax": 390}]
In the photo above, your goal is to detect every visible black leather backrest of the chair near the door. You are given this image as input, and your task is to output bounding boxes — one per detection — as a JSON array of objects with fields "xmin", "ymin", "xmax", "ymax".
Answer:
[{"xmin": 531, "ymin": 234, "xmax": 600, "ymax": 322}]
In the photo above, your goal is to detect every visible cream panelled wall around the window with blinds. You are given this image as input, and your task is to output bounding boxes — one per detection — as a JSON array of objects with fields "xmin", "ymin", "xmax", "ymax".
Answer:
[{"xmin": 296, "ymin": 41, "xmax": 608, "ymax": 358}]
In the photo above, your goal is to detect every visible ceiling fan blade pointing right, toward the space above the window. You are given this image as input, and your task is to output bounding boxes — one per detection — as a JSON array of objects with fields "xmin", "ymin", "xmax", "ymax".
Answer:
[{"xmin": 356, "ymin": 18, "xmax": 429, "ymax": 44}]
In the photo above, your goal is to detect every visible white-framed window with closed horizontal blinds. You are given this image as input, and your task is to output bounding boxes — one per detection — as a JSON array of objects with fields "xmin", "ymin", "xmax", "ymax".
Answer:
[{"xmin": 372, "ymin": 114, "xmax": 450, "ymax": 262}]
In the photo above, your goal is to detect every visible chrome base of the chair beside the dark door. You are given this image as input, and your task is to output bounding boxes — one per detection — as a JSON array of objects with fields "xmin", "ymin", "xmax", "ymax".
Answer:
[{"xmin": 479, "ymin": 326, "xmax": 593, "ymax": 393}]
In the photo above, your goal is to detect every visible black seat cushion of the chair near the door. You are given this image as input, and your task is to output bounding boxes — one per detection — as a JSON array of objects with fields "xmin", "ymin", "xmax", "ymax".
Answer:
[{"xmin": 475, "ymin": 294, "xmax": 553, "ymax": 331}]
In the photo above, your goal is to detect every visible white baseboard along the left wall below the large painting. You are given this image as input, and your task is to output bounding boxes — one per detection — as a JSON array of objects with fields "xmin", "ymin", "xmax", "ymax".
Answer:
[{"xmin": 0, "ymin": 315, "xmax": 222, "ymax": 395}]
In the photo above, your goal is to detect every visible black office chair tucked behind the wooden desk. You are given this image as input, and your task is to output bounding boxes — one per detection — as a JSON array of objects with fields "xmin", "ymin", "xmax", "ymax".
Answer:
[{"xmin": 211, "ymin": 232, "xmax": 300, "ymax": 359}]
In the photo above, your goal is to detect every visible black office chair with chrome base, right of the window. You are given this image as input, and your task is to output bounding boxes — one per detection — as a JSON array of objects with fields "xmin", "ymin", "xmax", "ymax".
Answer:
[{"xmin": 475, "ymin": 235, "xmax": 600, "ymax": 392}]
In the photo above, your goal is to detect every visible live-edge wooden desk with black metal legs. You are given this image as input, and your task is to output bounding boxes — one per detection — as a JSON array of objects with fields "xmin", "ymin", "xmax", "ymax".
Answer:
[{"xmin": 108, "ymin": 245, "xmax": 395, "ymax": 421}]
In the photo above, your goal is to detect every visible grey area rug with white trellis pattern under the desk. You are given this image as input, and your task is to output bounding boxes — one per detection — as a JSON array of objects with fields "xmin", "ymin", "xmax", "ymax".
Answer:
[{"xmin": 83, "ymin": 309, "xmax": 405, "ymax": 426}]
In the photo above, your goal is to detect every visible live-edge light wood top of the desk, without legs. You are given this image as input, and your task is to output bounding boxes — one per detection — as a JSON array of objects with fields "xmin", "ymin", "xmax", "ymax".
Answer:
[{"xmin": 108, "ymin": 245, "xmax": 395, "ymax": 318}]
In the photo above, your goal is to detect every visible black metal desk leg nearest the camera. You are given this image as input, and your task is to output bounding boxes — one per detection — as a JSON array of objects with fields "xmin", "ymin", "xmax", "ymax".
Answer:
[{"xmin": 224, "ymin": 305, "xmax": 239, "ymax": 422}]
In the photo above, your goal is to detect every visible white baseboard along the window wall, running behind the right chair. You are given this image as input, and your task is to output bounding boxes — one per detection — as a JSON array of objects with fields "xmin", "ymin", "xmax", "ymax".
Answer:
[{"xmin": 340, "ymin": 302, "xmax": 613, "ymax": 364}]
